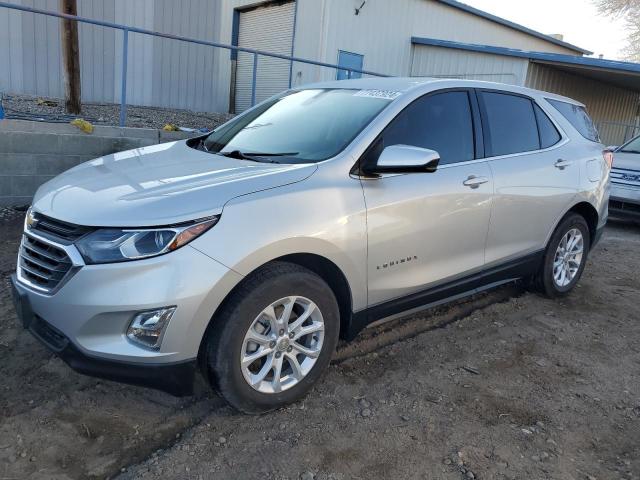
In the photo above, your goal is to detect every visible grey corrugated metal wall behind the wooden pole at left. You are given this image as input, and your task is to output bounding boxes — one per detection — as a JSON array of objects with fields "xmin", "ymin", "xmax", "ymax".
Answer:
[{"xmin": 0, "ymin": 0, "xmax": 228, "ymax": 111}]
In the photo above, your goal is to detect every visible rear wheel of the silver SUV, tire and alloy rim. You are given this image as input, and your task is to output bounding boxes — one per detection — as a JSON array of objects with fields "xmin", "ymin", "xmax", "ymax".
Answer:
[{"xmin": 535, "ymin": 213, "xmax": 591, "ymax": 298}]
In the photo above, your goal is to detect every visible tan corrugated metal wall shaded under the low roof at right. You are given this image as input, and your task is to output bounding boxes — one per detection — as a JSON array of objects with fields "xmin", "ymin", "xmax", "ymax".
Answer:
[{"xmin": 526, "ymin": 63, "xmax": 640, "ymax": 144}]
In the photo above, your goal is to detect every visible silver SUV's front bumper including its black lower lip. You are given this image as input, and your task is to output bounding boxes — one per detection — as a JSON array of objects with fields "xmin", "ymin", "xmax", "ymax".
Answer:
[{"xmin": 12, "ymin": 240, "xmax": 242, "ymax": 395}]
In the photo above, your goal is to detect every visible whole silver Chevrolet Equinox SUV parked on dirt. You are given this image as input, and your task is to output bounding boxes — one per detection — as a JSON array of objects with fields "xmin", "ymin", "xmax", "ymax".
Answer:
[{"xmin": 13, "ymin": 78, "xmax": 610, "ymax": 413}]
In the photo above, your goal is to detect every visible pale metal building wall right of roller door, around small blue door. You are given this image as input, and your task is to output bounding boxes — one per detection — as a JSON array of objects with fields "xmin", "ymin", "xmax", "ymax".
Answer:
[{"xmin": 294, "ymin": 0, "xmax": 576, "ymax": 89}]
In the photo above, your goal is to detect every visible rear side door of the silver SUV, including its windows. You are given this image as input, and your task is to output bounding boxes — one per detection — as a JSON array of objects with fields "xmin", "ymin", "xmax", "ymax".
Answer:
[{"xmin": 478, "ymin": 90, "xmax": 580, "ymax": 266}]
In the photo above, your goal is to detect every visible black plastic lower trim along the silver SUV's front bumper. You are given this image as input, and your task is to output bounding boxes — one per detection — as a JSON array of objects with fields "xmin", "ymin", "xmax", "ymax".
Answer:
[{"xmin": 11, "ymin": 275, "xmax": 197, "ymax": 396}]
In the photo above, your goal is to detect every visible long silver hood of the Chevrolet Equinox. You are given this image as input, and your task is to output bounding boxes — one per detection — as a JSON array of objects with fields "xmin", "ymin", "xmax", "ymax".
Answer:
[{"xmin": 33, "ymin": 141, "xmax": 317, "ymax": 227}]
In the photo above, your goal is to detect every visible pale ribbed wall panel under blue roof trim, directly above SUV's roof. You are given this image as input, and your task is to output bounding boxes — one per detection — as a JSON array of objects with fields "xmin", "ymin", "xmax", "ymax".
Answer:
[{"xmin": 411, "ymin": 45, "xmax": 529, "ymax": 85}]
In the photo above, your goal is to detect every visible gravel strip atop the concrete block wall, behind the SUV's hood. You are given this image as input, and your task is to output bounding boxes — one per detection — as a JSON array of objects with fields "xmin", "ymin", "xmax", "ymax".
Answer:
[{"xmin": 2, "ymin": 95, "xmax": 232, "ymax": 129}]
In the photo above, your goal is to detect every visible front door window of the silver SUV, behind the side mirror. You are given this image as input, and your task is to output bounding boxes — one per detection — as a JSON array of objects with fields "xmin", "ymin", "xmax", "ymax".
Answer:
[{"xmin": 365, "ymin": 91, "xmax": 475, "ymax": 165}]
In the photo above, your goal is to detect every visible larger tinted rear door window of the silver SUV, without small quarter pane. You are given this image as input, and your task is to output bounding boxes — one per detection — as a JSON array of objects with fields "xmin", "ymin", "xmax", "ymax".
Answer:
[{"xmin": 480, "ymin": 92, "xmax": 540, "ymax": 157}]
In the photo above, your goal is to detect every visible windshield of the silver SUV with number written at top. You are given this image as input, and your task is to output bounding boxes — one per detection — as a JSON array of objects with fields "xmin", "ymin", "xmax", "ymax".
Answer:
[{"xmin": 204, "ymin": 89, "xmax": 394, "ymax": 163}]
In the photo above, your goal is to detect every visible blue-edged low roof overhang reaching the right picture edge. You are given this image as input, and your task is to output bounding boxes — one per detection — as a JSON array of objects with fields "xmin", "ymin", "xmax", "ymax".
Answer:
[{"xmin": 411, "ymin": 37, "xmax": 640, "ymax": 91}]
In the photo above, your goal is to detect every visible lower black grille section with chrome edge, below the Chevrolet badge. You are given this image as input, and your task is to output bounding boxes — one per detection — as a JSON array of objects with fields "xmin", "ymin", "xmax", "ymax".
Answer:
[{"xmin": 18, "ymin": 233, "xmax": 72, "ymax": 292}]
